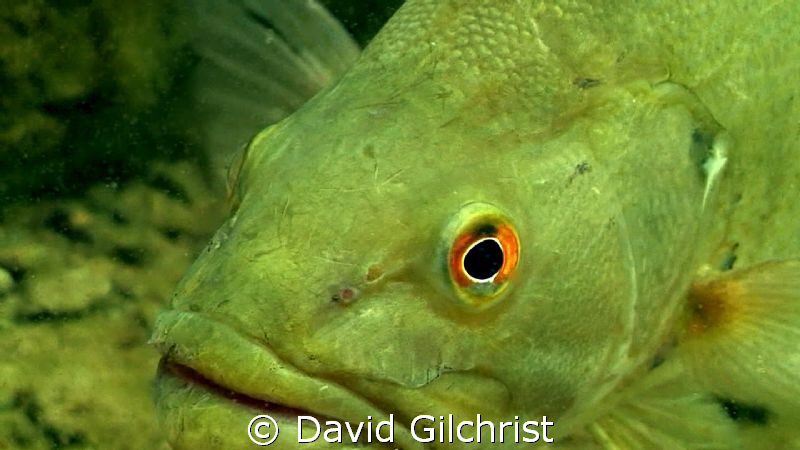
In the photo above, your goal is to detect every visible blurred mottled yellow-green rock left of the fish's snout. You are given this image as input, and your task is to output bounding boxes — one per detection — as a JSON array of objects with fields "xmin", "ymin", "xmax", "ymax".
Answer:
[{"xmin": 0, "ymin": 163, "xmax": 225, "ymax": 449}]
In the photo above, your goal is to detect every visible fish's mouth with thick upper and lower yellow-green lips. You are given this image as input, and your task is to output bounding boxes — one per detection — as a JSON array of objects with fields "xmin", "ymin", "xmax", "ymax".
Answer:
[{"xmin": 150, "ymin": 310, "xmax": 425, "ymax": 449}]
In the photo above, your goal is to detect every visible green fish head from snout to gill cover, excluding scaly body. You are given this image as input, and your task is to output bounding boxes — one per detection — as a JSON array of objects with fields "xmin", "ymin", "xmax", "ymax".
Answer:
[{"xmin": 156, "ymin": 0, "xmax": 720, "ymax": 442}]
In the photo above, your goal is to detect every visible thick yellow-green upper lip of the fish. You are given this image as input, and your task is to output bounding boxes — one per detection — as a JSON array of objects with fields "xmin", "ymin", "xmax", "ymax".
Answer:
[{"xmin": 149, "ymin": 310, "xmax": 426, "ymax": 449}]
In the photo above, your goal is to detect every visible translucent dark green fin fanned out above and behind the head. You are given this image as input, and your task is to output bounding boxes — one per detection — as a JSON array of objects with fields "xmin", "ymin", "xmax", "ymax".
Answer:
[{"xmin": 191, "ymin": 0, "xmax": 360, "ymax": 185}]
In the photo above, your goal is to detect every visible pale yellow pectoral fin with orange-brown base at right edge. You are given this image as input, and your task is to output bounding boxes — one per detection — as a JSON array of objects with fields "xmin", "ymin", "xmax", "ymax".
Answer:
[{"xmin": 677, "ymin": 260, "xmax": 800, "ymax": 421}]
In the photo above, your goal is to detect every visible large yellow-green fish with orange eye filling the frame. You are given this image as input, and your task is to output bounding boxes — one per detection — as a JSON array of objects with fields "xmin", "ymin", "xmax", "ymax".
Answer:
[{"xmin": 151, "ymin": 0, "xmax": 800, "ymax": 449}]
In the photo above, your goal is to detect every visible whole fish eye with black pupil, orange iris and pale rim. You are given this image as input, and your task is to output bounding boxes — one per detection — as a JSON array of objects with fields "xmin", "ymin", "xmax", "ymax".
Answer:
[{"xmin": 446, "ymin": 204, "xmax": 519, "ymax": 309}]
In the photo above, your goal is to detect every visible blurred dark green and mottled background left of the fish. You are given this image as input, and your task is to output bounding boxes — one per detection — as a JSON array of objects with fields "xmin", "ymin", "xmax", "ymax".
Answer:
[{"xmin": 0, "ymin": 0, "xmax": 402, "ymax": 449}]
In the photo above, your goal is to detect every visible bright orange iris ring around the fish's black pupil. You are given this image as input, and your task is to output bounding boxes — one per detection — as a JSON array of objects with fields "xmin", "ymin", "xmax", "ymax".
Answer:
[{"xmin": 448, "ymin": 223, "xmax": 519, "ymax": 293}]
